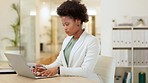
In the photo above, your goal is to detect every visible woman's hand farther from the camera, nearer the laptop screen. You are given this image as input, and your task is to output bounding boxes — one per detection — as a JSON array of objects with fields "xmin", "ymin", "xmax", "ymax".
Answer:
[{"xmin": 32, "ymin": 64, "xmax": 47, "ymax": 76}]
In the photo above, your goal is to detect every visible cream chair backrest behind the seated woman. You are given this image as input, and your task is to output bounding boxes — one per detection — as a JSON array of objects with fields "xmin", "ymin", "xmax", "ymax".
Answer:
[{"xmin": 95, "ymin": 56, "xmax": 116, "ymax": 83}]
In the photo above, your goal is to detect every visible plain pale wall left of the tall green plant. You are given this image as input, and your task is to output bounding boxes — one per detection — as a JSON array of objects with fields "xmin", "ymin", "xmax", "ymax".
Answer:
[{"xmin": 0, "ymin": 0, "xmax": 18, "ymax": 50}]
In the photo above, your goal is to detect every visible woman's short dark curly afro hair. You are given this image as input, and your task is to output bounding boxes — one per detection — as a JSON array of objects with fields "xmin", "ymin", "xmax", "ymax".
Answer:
[{"xmin": 57, "ymin": 0, "xmax": 88, "ymax": 23}]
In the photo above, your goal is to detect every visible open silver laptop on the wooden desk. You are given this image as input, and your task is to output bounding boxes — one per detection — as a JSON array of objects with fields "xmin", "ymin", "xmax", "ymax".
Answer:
[{"xmin": 5, "ymin": 53, "xmax": 47, "ymax": 78}]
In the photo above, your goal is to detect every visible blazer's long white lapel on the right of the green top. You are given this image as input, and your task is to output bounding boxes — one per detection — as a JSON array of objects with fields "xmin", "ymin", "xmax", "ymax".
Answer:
[{"xmin": 68, "ymin": 31, "xmax": 86, "ymax": 66}]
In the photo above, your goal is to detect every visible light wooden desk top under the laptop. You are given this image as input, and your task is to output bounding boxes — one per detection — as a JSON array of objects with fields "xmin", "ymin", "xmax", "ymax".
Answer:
[{"xmin": 0, "ymin": 74, "xmax": 97, "ymax": 83}]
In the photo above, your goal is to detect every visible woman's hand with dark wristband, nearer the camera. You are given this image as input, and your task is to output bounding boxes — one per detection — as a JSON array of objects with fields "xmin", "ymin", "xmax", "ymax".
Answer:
[{"xmin": 40, "ymin": 67, "xmax": 58, "ymax": 77}]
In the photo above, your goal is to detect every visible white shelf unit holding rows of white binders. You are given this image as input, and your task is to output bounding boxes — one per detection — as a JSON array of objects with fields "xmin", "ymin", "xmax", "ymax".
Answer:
[{"xmin": 112, "ymin": 26, "xmax": 148, "ymax": 83}]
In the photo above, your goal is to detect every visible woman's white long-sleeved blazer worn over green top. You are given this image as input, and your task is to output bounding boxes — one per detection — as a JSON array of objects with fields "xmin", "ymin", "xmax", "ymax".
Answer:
[{"xmin": 46, "ymin": 31, "xmax": 100, "ymax": 81}]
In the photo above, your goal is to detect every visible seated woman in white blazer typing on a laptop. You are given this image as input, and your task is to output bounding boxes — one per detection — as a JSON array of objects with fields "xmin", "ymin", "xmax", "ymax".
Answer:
[{"xmin": 34, "ymin": 1, "xmax": 101, "ymax": 83}]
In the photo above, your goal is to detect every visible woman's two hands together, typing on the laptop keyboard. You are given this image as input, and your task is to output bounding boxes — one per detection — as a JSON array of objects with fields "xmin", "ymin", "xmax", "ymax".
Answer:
[{"xmin": 32, "ymin": 64, "xmax": 58, "ymax": 77}]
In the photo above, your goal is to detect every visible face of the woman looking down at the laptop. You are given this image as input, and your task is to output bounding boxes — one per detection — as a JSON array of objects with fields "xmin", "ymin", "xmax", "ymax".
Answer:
[{"xmin": 61, "ymin": 16, "xmax": 81, "ymax": 36}]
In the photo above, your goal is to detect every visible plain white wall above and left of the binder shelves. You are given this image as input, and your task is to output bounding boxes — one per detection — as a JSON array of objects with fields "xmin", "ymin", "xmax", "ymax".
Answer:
[{"xmin": 101, "ymin": 0, "xmax": 148, "ymax": 56}]
